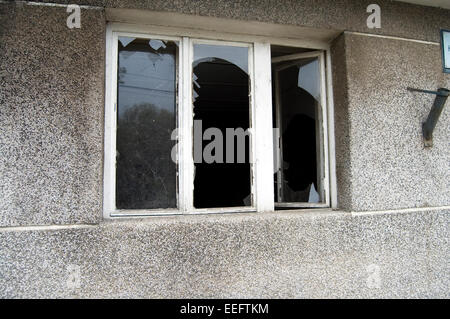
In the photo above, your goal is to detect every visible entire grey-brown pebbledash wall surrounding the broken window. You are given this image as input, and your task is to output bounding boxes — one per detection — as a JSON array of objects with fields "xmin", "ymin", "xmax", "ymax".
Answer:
[{"xmin": 0, "ymin": 0, "xmax": 450, "ymax": 298}]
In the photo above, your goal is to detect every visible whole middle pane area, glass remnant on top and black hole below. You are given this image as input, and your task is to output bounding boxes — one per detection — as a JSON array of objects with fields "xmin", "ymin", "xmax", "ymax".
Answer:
[{"xmin": 193, "ymin": 44, "xmax": 252, "ymax": 208}]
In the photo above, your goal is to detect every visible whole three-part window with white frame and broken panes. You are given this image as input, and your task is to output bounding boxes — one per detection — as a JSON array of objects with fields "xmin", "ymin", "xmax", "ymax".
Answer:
[{"xmin": 104, "ymin": 26, "xmax": 330, "ymax": 218}]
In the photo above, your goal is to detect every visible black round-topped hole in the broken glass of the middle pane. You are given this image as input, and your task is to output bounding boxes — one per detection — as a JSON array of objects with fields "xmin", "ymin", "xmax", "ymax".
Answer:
[{"xmin": 193, "ymin": 58, "xmax": 251, "ymax": 208}]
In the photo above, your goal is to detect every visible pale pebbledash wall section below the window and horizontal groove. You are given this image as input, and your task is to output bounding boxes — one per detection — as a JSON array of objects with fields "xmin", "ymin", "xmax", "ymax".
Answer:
[{"xmin": 0, "ymin": 211, "xmax": 450, "ymax": 298}]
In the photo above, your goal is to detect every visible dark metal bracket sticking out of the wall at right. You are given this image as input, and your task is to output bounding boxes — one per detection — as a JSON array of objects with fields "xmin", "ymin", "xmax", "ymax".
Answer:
[{"xmin": 407, "ymin": 88, "xmax": 450, "ymax": 147}]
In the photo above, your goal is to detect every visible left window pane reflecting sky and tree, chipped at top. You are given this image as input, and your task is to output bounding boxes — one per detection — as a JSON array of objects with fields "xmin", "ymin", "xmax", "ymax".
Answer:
[{"xmin": 116, "ymin": 37, "xmax": 178, "ymax": 209}]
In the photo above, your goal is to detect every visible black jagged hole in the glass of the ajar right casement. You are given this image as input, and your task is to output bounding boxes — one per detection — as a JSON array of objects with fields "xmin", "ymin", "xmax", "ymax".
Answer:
[{"xmin": 273, "ymin": 60, "xmax": 318, "ymax": 202}]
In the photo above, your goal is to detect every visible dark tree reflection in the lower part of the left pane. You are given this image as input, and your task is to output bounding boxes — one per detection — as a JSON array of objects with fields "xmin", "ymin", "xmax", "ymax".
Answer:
[{"xmin": 116, "ymin": 103, "xmax": 176, "ymax": 209}]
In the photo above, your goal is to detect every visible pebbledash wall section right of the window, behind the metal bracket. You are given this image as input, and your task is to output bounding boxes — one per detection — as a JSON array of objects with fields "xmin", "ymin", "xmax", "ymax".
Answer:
[{"xmin": 333, "ymin": 34, "xmax": 450, "ymax": 211}]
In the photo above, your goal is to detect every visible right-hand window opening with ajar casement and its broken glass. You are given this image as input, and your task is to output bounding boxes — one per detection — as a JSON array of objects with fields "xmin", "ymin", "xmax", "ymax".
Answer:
[{"xmin": 272, "ymin": 48, "xmax": 324, "ymax": 208}]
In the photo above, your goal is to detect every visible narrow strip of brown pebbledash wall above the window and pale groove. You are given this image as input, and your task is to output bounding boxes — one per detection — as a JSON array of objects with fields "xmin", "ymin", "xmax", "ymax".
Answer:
[{"xmin": 28, "ymin": 0, "xmax": 450, "ymax": 42}]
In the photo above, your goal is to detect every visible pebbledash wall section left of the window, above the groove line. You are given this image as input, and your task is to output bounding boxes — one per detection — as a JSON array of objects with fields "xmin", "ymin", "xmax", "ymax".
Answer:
[{"xmin": 0, "ymin": 4, "xmax": 105, "ymax": 226}]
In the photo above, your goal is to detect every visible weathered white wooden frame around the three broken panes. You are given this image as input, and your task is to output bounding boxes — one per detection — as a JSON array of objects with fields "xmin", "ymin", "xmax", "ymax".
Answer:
[{"xmin": 103, "ymin": 23, "xmax": 337, "ymax": 218}]
